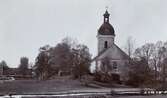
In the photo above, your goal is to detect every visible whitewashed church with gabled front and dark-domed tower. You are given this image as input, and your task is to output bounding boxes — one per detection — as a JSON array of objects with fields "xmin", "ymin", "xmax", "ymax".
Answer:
[{"xmin": 93, "ymin": 10, "xmax": 129, "ymax": 80}]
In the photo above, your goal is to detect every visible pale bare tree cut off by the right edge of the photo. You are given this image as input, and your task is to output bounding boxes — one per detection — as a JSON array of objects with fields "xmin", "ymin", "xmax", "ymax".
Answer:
[{"xmin": 149, "ymin": 41, "xmax": 167, "ymax": 87}]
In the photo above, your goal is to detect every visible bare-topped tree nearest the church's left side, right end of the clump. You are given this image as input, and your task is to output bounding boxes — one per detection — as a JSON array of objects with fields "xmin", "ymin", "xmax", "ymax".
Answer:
[{"xmin": 72, "ymin": 44, "xmax": 91, "ymax": 79}]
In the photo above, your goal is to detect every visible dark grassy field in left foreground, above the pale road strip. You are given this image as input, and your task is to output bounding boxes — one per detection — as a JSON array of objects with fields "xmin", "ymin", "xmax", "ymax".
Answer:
[{"xmin": 0, "ymin": 77, "xmax": 93, "ymax": 94}]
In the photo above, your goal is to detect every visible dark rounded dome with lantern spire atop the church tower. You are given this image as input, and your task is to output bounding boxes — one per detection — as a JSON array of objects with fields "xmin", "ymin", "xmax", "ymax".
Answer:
[{"xmin": 98, "ymin": 10, "xmax": 115, "ymax": 36}]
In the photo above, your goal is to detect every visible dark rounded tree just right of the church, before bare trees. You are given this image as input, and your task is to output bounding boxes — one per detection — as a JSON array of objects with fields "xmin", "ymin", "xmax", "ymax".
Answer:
[{"xmin": 127, "ymin": 58, "xmax": 152, "ymax": 87}]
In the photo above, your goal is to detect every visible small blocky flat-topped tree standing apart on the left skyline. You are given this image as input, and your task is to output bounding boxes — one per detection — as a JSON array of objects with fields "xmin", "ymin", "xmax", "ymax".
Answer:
[{"xmin": 19, "ymin": 57, "xmax": 29, "ymax": 75}]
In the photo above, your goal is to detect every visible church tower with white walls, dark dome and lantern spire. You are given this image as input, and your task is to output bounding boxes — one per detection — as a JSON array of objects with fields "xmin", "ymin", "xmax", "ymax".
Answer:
[{"xmin": 97, "ymin": 10, "xmax": 115, "ymax": 54}]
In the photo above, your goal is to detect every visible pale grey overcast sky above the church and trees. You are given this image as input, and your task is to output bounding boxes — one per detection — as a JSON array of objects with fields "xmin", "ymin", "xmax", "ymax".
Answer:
[{"xmin": 0, "ymin": 0, "xmax": 167, "ymax": 67}]
